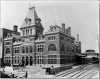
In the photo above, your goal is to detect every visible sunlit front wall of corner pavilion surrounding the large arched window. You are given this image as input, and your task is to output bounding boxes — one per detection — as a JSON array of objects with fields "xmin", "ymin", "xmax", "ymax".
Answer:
[{"xmin": 45, "ymin": 33, "xmax": 60, "ymax": 66}]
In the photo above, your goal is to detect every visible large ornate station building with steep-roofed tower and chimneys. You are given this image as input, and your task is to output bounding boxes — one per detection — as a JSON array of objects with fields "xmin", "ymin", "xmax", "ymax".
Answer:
[{"xmin": 4, "ymin": 7, "xmax": 81, "ymax": 66}]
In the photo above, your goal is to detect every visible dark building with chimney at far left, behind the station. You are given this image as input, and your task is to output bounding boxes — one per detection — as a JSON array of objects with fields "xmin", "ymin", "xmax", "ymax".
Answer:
[{"xmin": 0, "ymin": 25, "xmax": 20, "ymax": 65}]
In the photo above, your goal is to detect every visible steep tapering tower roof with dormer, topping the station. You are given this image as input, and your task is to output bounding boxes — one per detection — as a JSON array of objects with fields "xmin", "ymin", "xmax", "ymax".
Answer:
[{"xmin": 21, "ymin": 6, "xmax": 39, "ymax": 27}]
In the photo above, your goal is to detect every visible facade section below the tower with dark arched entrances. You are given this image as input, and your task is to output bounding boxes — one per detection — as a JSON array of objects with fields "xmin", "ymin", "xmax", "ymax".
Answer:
[{"xmin": 13, "ymin": 41, "xmax": 35, "ymax": 65}]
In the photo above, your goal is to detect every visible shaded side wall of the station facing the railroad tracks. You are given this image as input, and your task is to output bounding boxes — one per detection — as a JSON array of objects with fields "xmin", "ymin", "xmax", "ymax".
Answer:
[{"xmin": 60, "ymin": 34, "xmax": 75, "ymax": 65}]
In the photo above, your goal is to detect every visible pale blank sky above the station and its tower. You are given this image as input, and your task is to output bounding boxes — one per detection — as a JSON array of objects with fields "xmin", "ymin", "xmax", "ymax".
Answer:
[{"xmin": 1, "ymin": 0, "xmax": 99, "ymax": 52}]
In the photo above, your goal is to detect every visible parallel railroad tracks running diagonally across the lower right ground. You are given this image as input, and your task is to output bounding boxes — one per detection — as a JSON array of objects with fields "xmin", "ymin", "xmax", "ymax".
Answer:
[{"xmin": 56, "ymin": 65, "xmax": 94, "ymax": 79}]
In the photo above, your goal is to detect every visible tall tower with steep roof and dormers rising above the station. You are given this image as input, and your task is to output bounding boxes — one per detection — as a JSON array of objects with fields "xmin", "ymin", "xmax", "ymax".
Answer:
[{"xmin": 20, "ymin": 7, "xmax": 44, "ymax": 38}]
